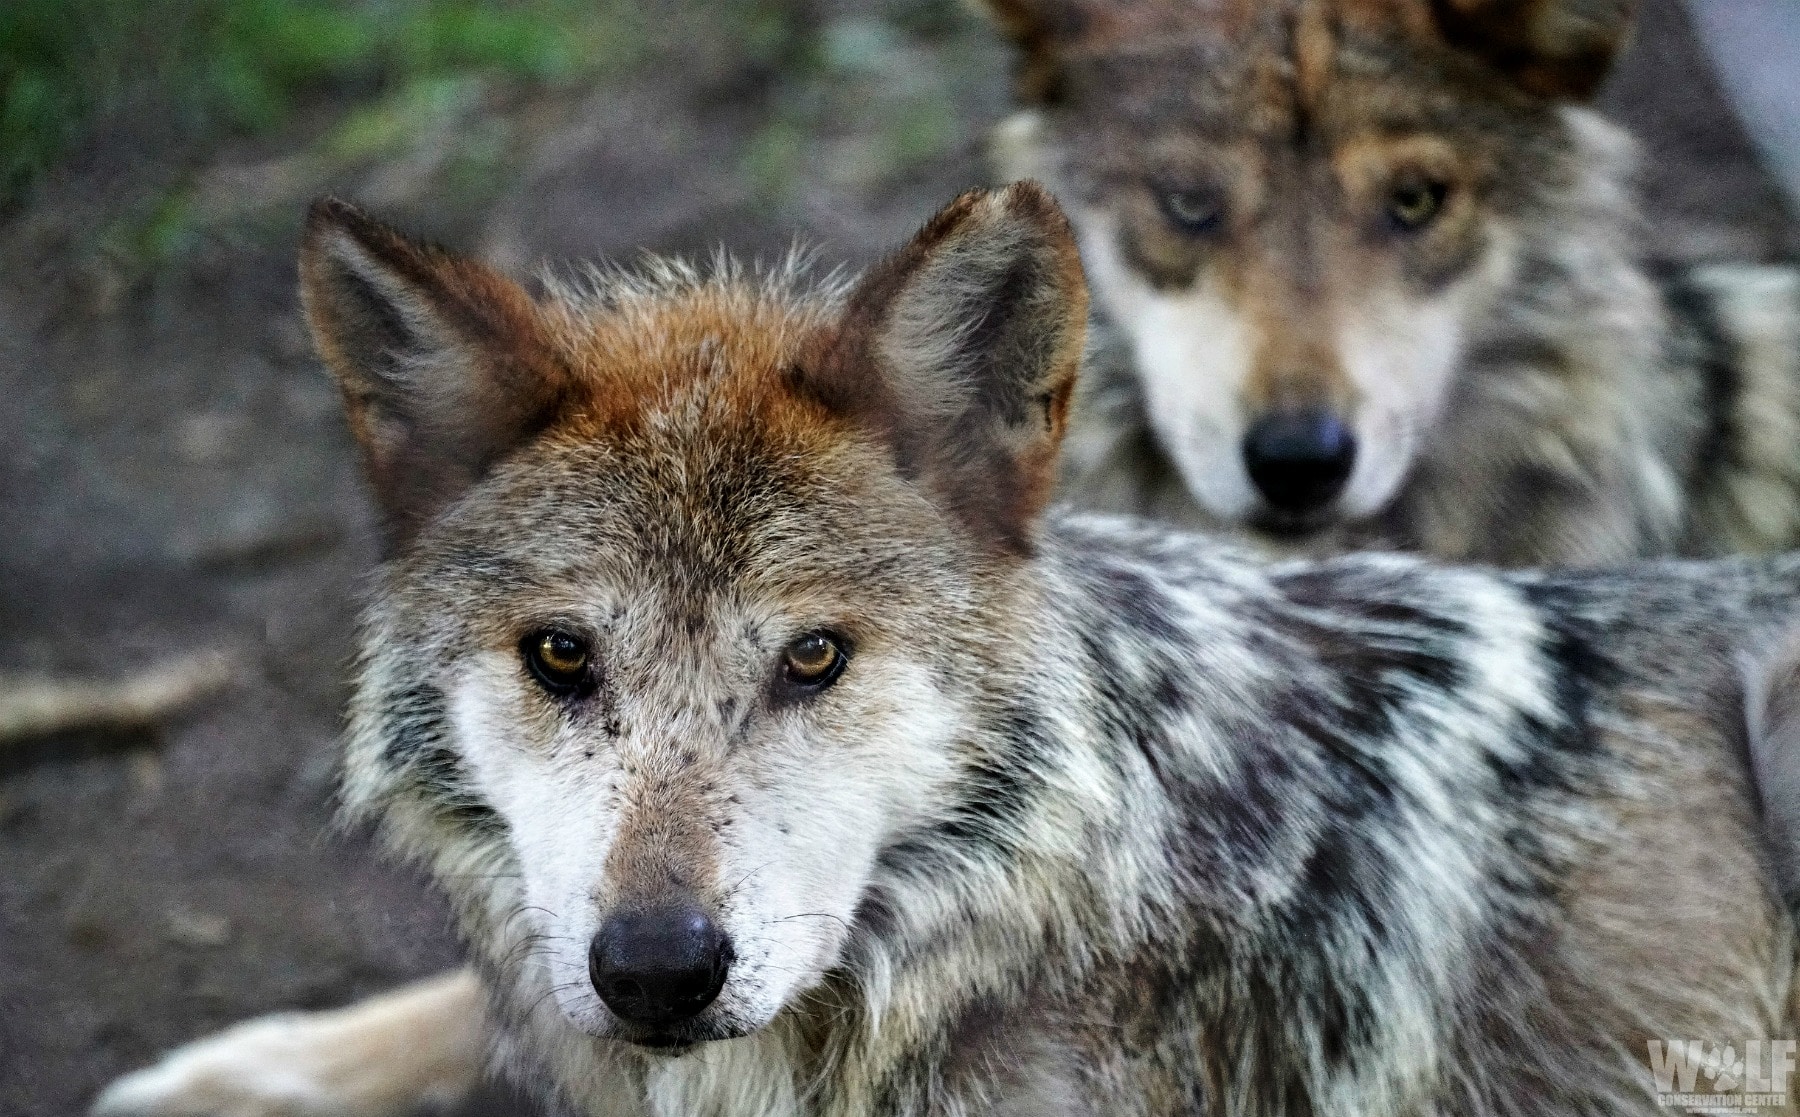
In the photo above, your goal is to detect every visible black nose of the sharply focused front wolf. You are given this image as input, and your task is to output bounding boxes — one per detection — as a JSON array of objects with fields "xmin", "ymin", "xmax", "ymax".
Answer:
[{"xmin": 587, "ymin": 903, "xmax": 733, "ymax": 1027}]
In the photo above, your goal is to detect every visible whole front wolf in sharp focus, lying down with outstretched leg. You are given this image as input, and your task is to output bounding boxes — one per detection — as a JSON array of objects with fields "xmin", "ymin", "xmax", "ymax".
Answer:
[{"xmin": 101, "ymin": 185, "xmax": 1800, "ymax": 1117}]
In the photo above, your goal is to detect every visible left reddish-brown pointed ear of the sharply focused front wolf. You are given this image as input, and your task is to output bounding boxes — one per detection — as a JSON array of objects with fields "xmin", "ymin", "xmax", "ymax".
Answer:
[{"xmin": 301, "ymin": 198, "xmax": 562, "ymax": 552}]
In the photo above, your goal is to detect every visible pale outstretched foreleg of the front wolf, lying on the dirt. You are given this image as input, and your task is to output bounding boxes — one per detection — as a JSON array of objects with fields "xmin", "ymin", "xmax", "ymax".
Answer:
[{"xmin": 92, "ymin": 970, "xmax": 488, "ymax": 1117}]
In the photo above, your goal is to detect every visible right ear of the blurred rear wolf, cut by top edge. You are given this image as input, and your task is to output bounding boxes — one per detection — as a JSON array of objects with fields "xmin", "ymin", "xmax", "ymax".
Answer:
[{"xmin": 1433, "ymin": 0, "xmax": 1638, "ymax": 99}]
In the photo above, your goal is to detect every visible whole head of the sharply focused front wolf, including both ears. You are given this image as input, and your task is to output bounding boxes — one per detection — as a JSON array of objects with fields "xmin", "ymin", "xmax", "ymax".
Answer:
[{"xmin": 302, "ymin": 183, "xmax": 1085, "ymax": 1047}]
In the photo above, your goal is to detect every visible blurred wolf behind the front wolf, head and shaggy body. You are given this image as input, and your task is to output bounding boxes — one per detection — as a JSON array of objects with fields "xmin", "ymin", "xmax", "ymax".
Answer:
[{"xmin": 983, "ymin": 0, "xmax": 1800, "ymax": 565}]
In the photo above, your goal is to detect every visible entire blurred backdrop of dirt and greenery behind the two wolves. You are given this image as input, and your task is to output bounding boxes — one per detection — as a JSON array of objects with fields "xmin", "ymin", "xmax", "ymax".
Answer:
[{"xmin": 0, "ymin": 0, "xmax": 1800, "ymax": 1117}]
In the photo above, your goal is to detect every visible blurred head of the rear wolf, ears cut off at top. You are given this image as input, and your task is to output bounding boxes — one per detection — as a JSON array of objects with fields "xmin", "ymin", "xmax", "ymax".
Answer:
[{"xmin": 986, "ymin": 0, "xmax": 1633, "ymax": 534}]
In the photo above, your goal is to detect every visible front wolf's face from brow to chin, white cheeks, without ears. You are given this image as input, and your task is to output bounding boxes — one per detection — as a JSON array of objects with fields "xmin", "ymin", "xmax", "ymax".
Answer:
[{"xmin": 394, "ymin": 444, "xmax": 968, "ymax": 1043}]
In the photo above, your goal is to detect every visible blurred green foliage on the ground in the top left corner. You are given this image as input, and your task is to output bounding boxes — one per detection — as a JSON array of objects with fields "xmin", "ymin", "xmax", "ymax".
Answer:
[{"xmin": 0, "ymin": 0, "xmax": 639, "ymax": 205}]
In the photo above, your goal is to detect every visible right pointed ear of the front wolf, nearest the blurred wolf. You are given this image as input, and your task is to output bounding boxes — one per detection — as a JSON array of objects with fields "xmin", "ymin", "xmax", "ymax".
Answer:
[{"xmin": 801, "ymin": 182, "xmax": 1087, "ymax": 552}]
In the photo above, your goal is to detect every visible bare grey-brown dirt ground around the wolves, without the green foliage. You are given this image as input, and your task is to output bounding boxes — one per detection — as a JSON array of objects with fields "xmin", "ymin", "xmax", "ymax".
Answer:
[{"xmin": 0, "ymin": 0, "xmax": 1800, "ymax": 1117}]
